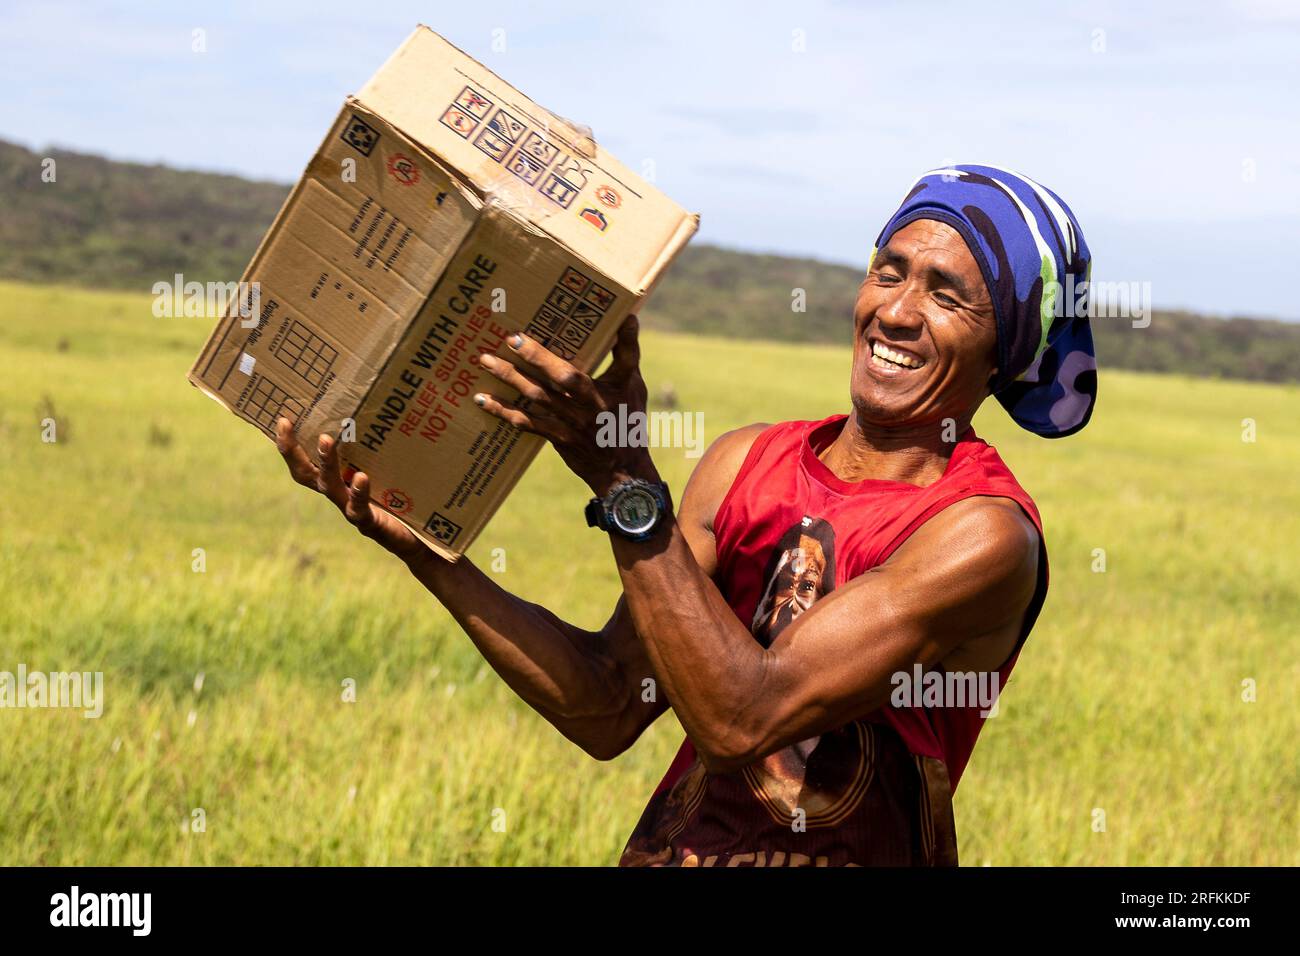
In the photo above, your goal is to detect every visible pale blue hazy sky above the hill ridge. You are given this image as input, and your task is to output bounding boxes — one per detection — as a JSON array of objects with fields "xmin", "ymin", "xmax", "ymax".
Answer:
[{"xmin": 0, "ymin": 0, "xmax": 1300, "ymax": 319}]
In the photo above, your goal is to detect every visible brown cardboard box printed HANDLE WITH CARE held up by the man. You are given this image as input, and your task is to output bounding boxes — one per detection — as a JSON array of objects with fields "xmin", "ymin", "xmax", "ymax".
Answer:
[{"xmin": 190, "ymin": 26, "xmax": 699, "ymax": 561}]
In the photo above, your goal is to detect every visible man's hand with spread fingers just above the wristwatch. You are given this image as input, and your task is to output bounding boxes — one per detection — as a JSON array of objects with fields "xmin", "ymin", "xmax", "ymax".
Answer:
[{"xmin": 475, "ymin": 315, "xmax": 658, "ymax": 496}]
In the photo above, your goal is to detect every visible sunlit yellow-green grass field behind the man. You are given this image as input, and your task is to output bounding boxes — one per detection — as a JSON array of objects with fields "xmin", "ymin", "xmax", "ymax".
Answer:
[{"xmin": 0, "ymin": 284, "xmax": 1300, "ymax": 865}]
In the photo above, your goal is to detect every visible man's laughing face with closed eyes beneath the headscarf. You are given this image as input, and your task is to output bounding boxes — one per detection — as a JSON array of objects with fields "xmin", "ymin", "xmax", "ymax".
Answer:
[{"xmin": 850, "ymin": 220, "xmax": 997, "ymax": 428}]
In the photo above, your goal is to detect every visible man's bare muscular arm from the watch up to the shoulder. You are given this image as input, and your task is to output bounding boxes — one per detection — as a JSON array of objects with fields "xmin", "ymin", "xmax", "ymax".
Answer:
[{"xmin": 603, "ymin": 489, "xmax": 1039, "ymax": 770}]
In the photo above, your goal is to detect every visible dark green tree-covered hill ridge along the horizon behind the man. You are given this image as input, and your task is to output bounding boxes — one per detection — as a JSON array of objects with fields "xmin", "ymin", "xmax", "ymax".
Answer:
[{"xmin": 0, "ymin": 140, "xmax": 1300, "ymax": 381}]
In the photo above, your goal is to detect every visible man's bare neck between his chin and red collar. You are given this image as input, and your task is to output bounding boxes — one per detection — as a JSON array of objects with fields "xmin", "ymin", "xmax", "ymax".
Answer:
[{"xmin": 818, "ymin": 412, "xmax": 970, "ymax": 486}]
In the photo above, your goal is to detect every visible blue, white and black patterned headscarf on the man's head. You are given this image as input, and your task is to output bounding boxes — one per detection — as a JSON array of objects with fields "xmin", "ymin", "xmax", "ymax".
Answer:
[{"xmin": 868, "ymin": 165, "xmax": 1097, "ymax": 438}]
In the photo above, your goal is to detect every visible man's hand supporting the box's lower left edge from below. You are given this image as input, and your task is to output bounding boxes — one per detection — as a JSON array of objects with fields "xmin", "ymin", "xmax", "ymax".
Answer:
[{"xmin": 276, "ymin": 418, "xmax": 432, "ymax": 564}]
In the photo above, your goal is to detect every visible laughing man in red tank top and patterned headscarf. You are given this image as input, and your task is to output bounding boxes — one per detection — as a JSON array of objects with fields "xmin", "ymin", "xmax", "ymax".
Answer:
[{"xmin": 278, "ymin": 166, "xmax": 1096, "ymax": 866}]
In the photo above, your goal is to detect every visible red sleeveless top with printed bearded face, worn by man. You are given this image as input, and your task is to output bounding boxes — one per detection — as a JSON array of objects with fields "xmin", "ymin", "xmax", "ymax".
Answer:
[{"xmin": 620, "ymin": 415, "xmax": 1048, "ymax": 866}]
